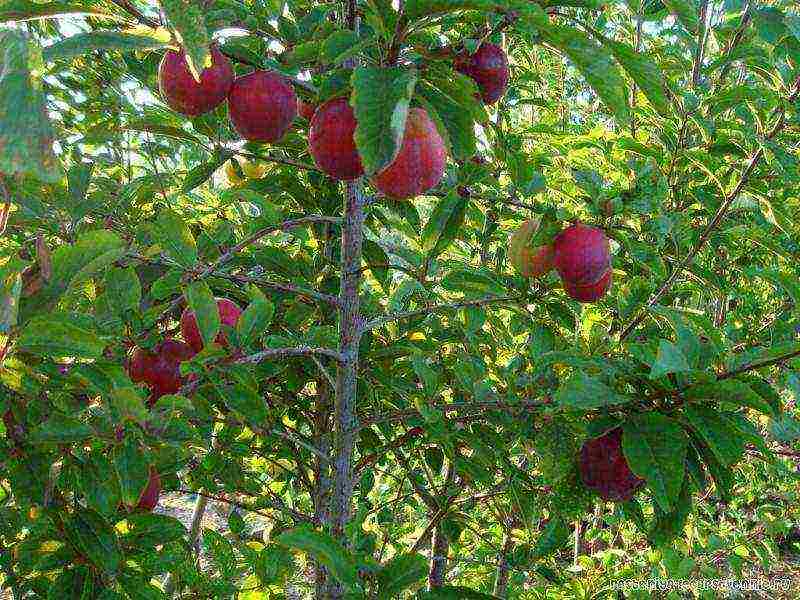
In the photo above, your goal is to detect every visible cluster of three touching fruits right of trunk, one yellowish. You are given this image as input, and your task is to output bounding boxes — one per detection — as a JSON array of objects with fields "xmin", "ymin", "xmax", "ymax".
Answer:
[{"xmin": 509, "ymin": 219, "xmax": 612, "ymax": 302}]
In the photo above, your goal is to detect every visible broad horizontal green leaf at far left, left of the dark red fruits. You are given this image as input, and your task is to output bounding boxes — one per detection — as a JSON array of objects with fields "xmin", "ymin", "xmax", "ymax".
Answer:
[{"xmin": 19, "ymin": 313, "xmax": 106, "ymax": 358}]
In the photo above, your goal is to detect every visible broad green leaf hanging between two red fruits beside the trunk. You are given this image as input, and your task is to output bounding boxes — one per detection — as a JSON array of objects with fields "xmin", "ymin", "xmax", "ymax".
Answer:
[{"xmin": 350, "ymin": 67, "xmax": 417, "ymax": 175}]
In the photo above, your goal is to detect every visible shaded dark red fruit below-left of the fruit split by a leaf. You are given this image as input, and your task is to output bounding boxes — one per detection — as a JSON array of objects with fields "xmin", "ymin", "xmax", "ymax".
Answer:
[{"xmin": 128, "ymin": 340, "xmax": 195, "ymax": 406}]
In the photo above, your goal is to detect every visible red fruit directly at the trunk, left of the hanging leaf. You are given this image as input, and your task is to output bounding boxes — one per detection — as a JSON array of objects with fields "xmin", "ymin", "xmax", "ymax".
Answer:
[{"xmin": 308, "ymin": 98, "xmax": 364, "ymax": 180}]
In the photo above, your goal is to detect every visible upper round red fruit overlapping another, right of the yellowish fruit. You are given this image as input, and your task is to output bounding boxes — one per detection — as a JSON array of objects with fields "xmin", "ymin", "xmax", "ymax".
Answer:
[{"xmin": 553, "ymin": 223, "xmax": 611, "ymax": 286}]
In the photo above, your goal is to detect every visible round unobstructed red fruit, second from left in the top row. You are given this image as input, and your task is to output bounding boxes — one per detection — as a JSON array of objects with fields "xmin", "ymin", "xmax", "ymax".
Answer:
[{"xmin": 228, "ymin": 71, "xmax": 297, "ymax": 142}]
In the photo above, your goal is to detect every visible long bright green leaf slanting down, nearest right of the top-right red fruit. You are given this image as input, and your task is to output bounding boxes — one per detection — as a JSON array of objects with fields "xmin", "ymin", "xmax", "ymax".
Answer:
[{"xmin": 541, "ymin": 26, "xmax": 630, "ymax": 122}]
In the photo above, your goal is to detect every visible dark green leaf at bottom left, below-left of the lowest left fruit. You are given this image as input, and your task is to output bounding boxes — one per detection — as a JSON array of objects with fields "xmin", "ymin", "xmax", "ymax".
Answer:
[{"xmin": 64, "ymin": 507, "xmax": 124, "ymax": 574}]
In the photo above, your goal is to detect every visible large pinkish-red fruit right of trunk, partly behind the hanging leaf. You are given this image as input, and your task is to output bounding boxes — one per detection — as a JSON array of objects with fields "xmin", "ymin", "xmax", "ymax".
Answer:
[{"xmin": 372, "ymin": 108, "xmax": 447, "ymax": 200}]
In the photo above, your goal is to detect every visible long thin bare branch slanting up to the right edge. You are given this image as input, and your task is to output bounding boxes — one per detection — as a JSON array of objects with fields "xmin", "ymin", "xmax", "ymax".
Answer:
[{"xmin": 619, "ymin": 77, "xmax": 800, "ymax": 342}]
